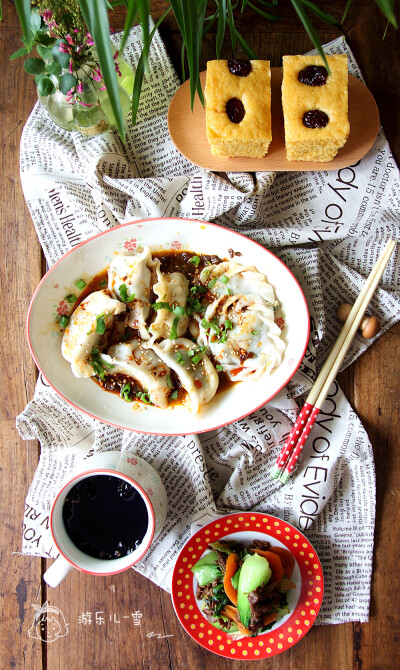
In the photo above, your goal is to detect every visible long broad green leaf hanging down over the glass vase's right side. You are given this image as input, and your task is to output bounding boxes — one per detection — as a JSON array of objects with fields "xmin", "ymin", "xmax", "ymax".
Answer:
[{"xmin": 79, "ymin": 0, "xmax": 125, "ymax": 141}]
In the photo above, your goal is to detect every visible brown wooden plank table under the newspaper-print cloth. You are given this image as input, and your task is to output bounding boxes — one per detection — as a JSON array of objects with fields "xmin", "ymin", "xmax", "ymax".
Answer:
[{"xmin": 0, "ymin": 0, "xmax": 400, "ymax": 670}]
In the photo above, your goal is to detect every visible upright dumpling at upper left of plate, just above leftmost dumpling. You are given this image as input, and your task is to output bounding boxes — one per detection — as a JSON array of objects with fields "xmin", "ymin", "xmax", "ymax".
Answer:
[{"xmin": 108, "ymin": 247, "xmax": 160, "ymax": 340}]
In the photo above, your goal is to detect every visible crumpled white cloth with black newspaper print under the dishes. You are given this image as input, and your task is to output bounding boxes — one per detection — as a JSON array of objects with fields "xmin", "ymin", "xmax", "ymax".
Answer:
[{"xmin": 17, "ymin": 30, "xmax": 400, "ymax": 624}]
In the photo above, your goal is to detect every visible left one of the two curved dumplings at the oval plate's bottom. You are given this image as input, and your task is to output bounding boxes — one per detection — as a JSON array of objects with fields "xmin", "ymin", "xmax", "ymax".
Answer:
[{"xmin": 100, "ymin": 339, "xmax": 171, "ymax": 408}]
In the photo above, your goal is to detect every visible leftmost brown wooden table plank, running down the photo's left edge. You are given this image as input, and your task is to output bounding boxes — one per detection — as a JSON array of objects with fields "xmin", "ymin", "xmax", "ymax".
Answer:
[{"xmin": 0, "ymin": 2, "xmax": 42, "ymax": 670}]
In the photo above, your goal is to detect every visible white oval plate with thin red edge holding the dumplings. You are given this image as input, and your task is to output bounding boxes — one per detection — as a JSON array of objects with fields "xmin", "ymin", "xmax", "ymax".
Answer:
[{"xmin": 27, "ymin": 218, "xmax": 309, "ymax": 435}]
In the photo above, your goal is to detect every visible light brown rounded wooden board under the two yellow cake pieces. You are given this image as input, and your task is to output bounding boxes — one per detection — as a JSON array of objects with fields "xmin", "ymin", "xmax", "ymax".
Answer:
[{"xmin": 168, "ymin": 67, "xmax": 379, "ymax": 172}]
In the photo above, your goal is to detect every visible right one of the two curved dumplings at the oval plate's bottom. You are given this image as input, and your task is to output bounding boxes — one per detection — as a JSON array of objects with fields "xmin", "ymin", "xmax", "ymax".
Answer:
[{"xmin": 150, "ymin": 337, "xmax": 218, "ymax": 414}]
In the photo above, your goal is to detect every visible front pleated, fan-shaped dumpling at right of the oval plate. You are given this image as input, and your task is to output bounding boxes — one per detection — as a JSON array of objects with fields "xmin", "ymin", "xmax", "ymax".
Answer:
[{"xmin": 198, "ymin": 294, "xmax": 285, "ymax": 381}]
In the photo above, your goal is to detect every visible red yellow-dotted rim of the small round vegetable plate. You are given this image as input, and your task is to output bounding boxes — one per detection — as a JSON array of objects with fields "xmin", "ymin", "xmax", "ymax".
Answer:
[{"xmin": 172, "ymin": 512, "xmax": 324, "ymax": 661}]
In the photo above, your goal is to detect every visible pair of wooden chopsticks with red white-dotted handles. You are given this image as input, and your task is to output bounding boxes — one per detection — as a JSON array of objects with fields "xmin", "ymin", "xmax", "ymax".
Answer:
[{"xmin": 270, "ymin": 240, "xmax": 396, "ymax": 484}]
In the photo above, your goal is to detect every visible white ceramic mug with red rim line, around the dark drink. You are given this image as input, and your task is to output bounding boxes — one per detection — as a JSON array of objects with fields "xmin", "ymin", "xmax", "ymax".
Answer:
[{"xmin": 43, "ymin": 468, "xmax": 156, "ymax": 587}]
